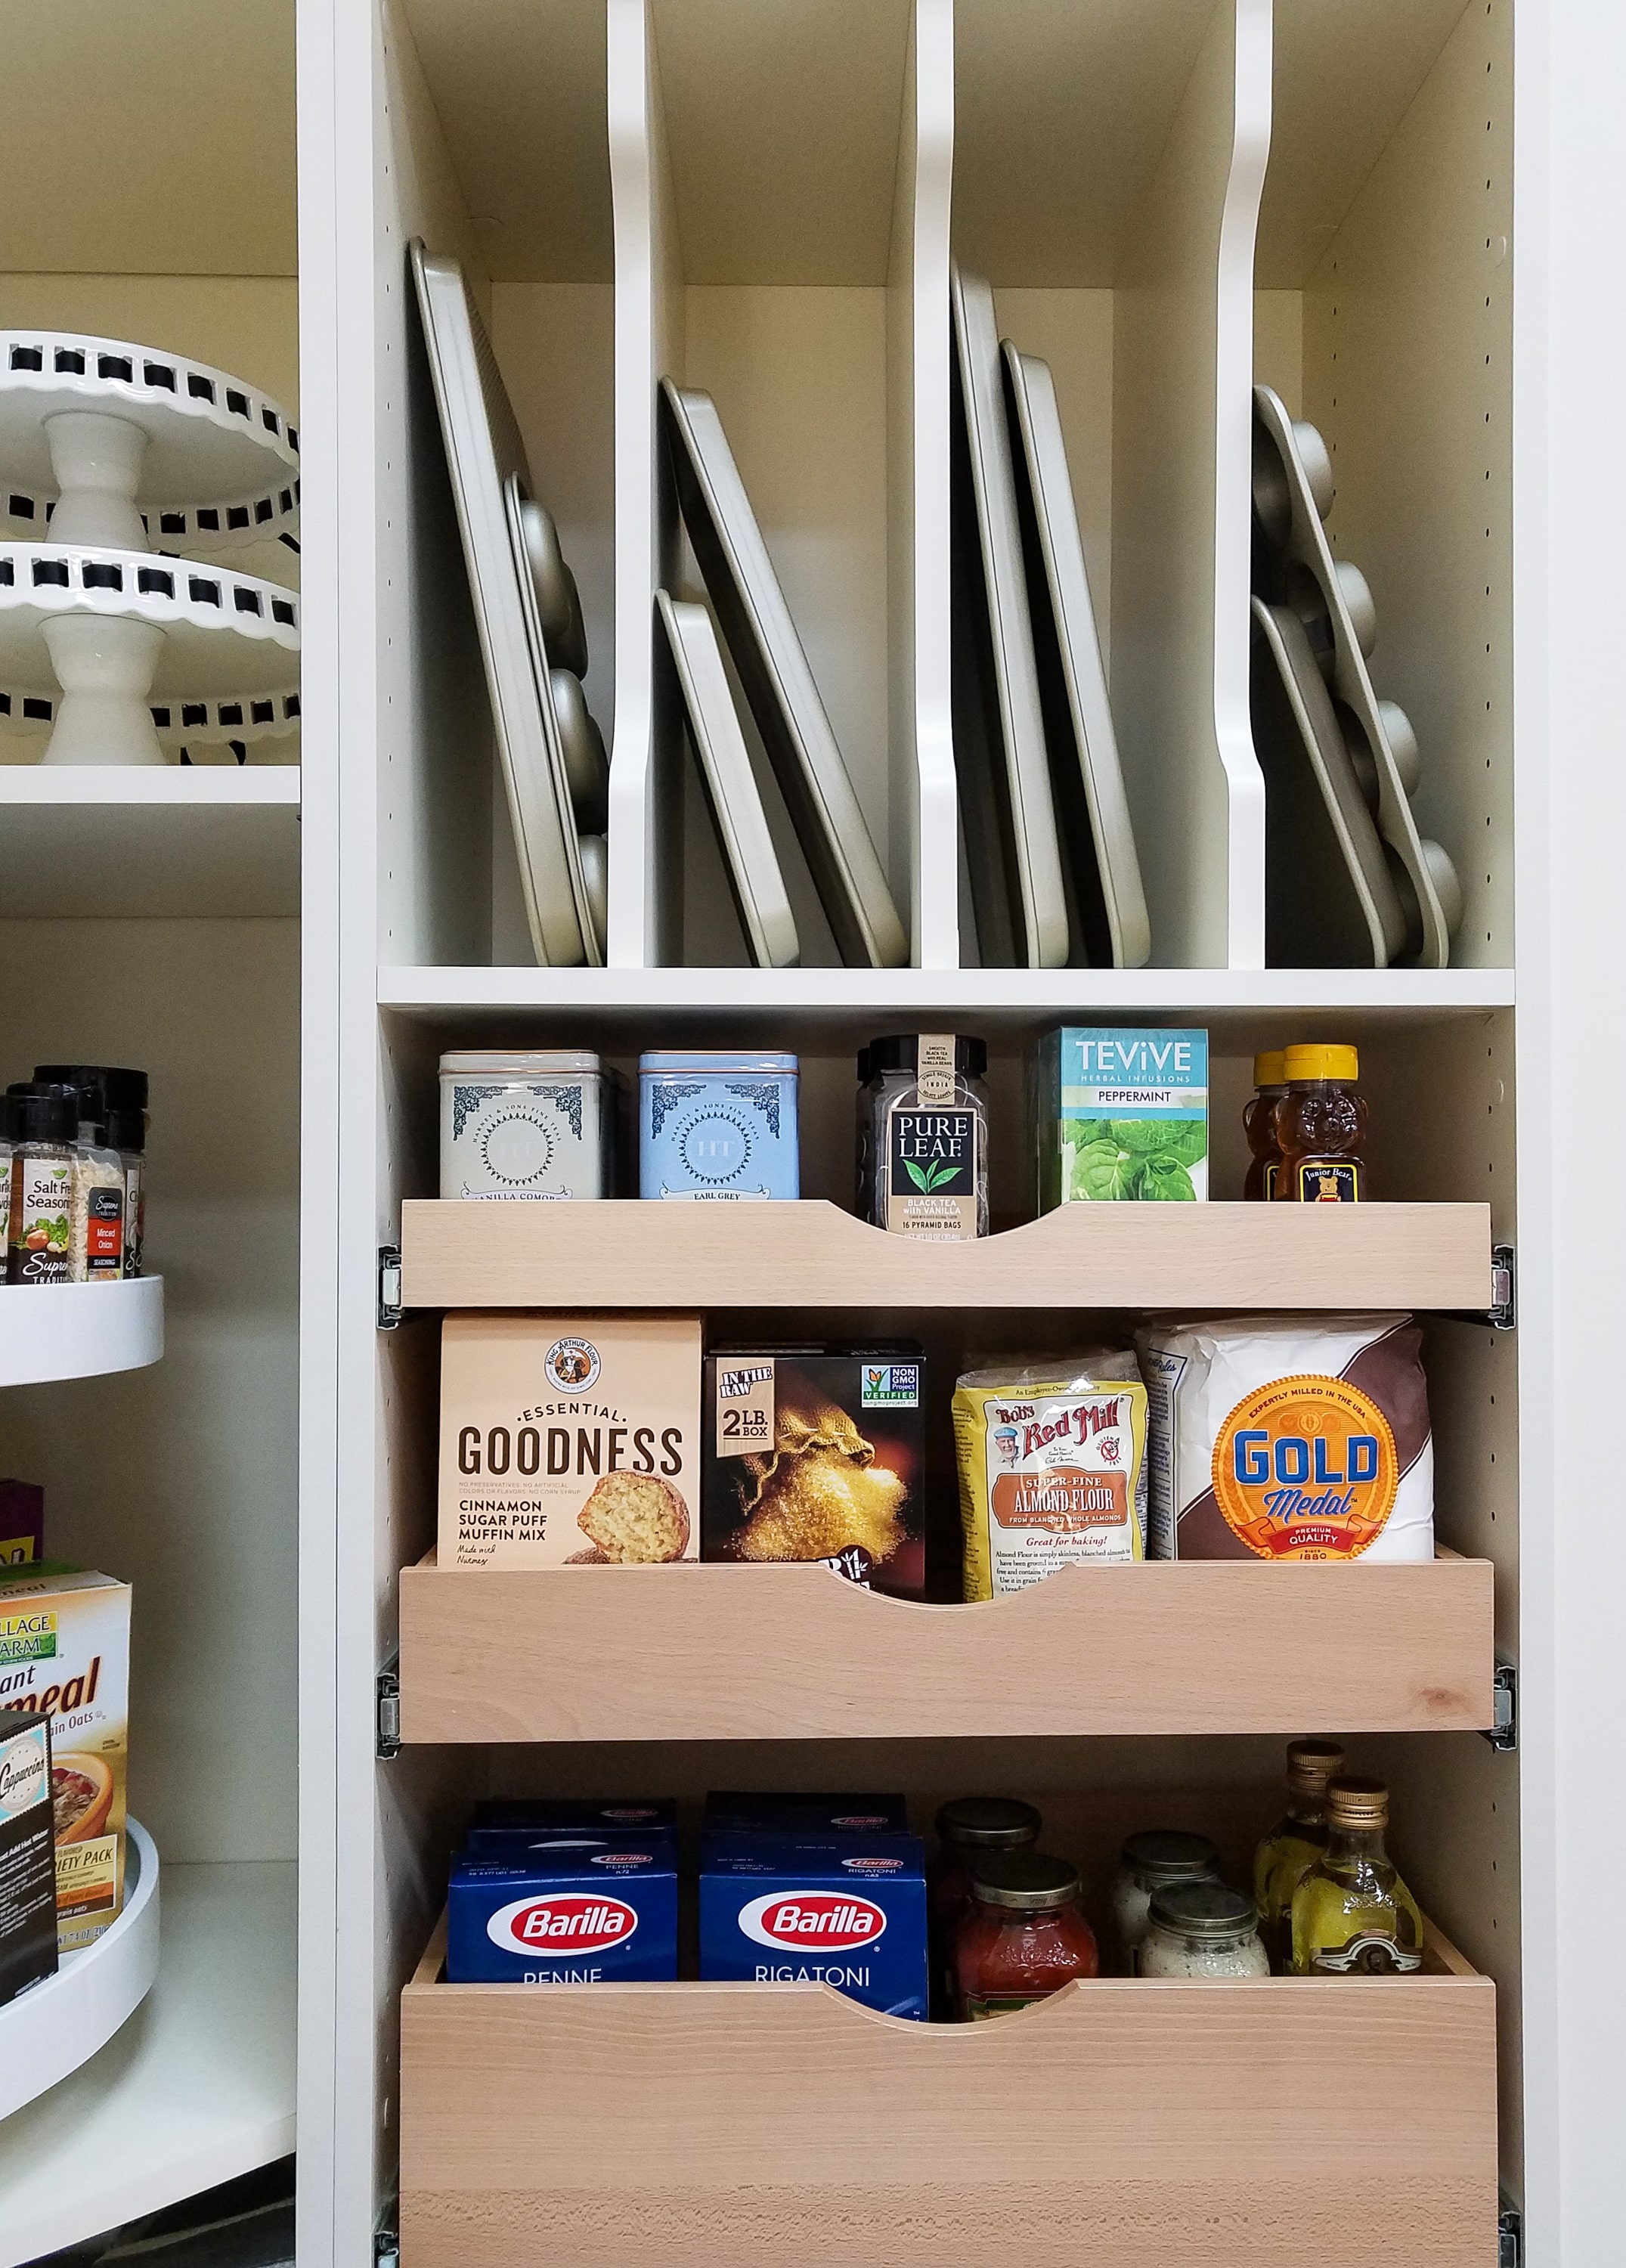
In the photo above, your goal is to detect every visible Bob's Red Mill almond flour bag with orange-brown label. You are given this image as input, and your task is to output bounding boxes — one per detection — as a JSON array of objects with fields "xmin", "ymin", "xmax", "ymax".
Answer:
[{"xmin": 955, "ymin": 1352, "xmax": 1145, "ymax": 1599}]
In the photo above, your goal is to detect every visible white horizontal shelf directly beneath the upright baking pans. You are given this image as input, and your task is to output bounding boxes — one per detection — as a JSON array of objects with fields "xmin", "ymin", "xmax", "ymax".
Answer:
[{"xmin": 379, "ymin": 966, "xmax": 1513, "ymax": 1030}]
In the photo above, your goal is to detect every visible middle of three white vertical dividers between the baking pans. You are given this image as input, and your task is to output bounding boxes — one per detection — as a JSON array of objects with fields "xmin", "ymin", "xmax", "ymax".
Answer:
[{"xmin": 887, "ymin": 0, "xmax": 959, "ymax": 968}]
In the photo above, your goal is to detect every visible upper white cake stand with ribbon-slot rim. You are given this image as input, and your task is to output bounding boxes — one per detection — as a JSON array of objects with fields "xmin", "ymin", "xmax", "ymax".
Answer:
[{"xmin": 0, "ymin": 331, "xmax": 299, "ymax": 551}]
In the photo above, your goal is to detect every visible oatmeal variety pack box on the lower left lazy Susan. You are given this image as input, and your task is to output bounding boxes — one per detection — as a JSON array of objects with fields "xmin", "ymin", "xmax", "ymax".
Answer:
[{"xmin": 0, "ymin": 1560, "xmax": 129, "ymax": 1953}]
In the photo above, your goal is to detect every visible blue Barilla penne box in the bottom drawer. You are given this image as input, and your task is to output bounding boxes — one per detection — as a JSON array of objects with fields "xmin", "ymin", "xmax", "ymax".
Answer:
[{"xmin": 447, "ymin": 1833, "xmax": 678, "ymax": 1984}]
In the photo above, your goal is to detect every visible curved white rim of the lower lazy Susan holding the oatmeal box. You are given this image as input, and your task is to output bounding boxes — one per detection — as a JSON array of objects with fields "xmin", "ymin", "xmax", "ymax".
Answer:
[{"xmin": 0, "ymin": 1819, "xmax": 159, "ymax": 2118}]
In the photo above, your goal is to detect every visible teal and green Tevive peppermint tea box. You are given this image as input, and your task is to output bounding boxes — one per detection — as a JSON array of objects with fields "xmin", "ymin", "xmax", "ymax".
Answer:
[{"xmin": 1032, "ymin": 1025, "xmax": 1209, "ymax": 1213}]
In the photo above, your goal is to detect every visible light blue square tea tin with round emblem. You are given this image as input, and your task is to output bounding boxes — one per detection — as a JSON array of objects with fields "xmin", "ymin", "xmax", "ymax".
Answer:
[{"xmin": 637, "ymin": 1048, "xmax": 801, "ymax": 1200}]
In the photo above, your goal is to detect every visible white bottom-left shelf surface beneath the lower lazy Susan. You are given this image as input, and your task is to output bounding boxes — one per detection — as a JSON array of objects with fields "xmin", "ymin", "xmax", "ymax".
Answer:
[{"xmin": 0, "ymin": 1862, "xmax": 297, "ymax": 2268}]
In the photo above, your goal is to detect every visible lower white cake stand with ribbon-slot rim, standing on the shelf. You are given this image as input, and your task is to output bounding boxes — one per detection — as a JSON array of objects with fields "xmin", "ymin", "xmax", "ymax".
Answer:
[{"xmin": 0, "ymin": 544, "xmax": 299, "ymax": 764}]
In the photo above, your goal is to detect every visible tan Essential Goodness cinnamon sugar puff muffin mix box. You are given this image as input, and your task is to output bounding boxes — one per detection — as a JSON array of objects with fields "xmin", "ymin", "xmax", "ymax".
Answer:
[{"xmin": 440, "ymin": 1315, "xmax": 701, "ymax": 1567}]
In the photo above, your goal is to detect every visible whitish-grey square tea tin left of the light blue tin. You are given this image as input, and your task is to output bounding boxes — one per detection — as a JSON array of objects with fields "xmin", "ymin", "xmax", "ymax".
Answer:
[{"xmin": 440, "ymin": 1048, "xmax": 615, "ymax": 1200}]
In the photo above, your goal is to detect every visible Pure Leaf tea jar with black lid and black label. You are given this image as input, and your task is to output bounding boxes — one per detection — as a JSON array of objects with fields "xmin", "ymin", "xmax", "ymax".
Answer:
[{"xmin": 859, "ymin": 1032, "xmax": 989, "ymax": 1243}]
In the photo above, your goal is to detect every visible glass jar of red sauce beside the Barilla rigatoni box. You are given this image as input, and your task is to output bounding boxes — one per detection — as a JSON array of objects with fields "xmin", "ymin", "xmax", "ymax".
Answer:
[{"xmin": 955, "ymin": 1851, "xmax": 1100, "ymax": 2023}]
